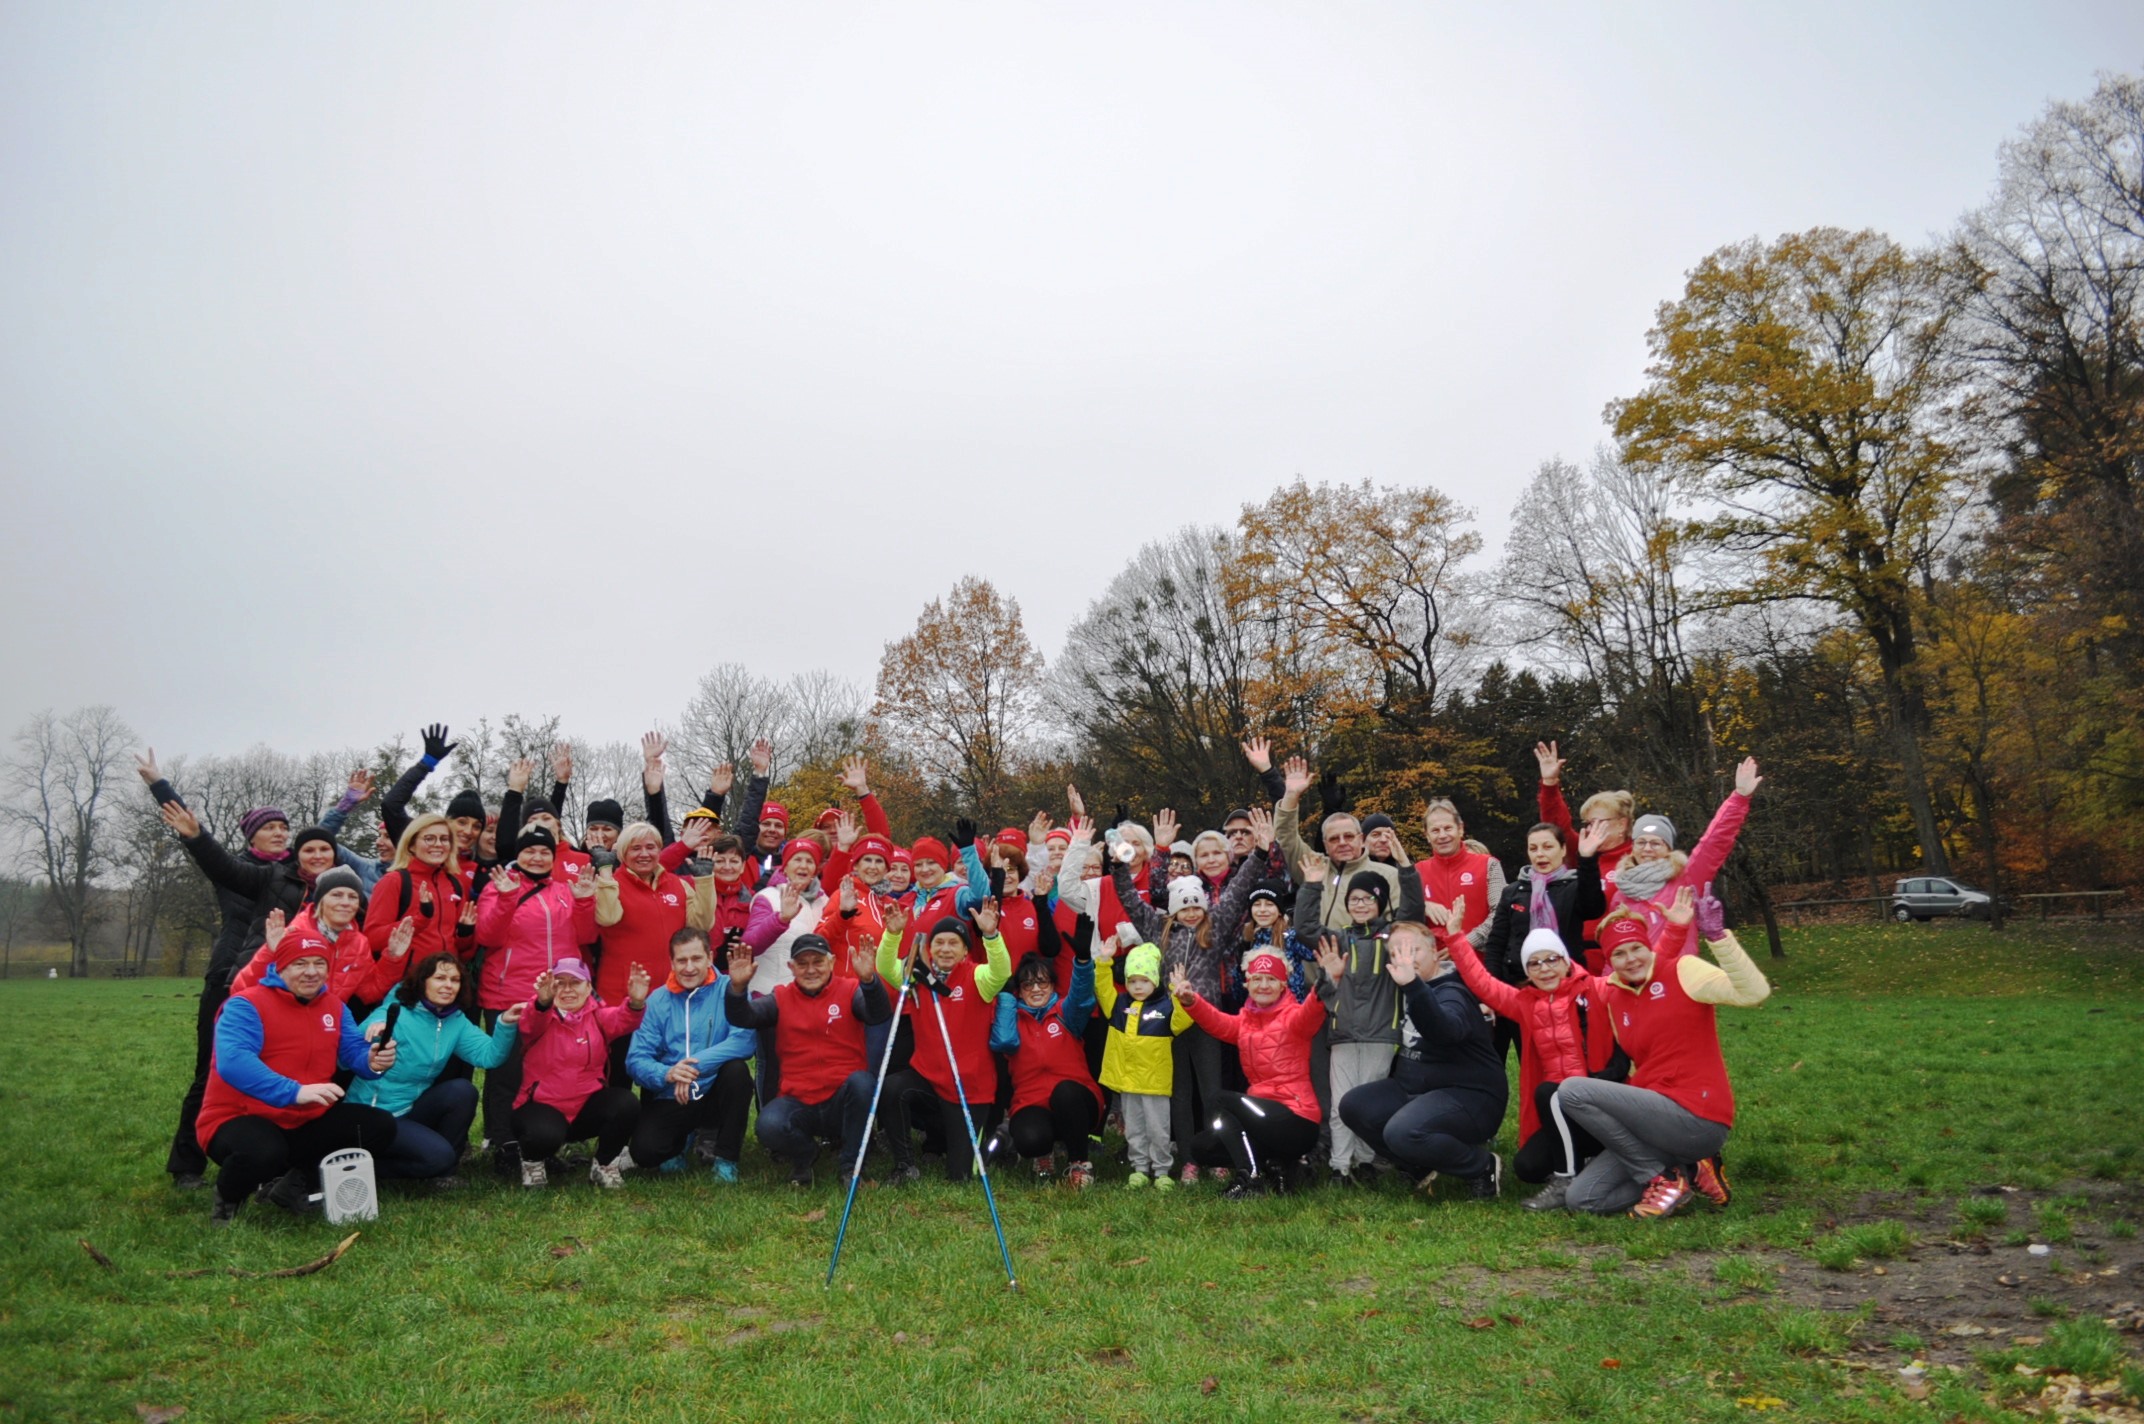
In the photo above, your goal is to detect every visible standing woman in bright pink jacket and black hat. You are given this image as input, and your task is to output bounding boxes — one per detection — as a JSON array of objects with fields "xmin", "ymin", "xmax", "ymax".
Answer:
[{"xmin": 476, "ymin": 826, "xmax": 596, "ymax": 1177}]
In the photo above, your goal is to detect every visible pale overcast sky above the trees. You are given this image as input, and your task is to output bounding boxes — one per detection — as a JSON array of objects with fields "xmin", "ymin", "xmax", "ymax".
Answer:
[{"xmin": 0, "ymin": 0, "xmax": 2144, "ymax": 755}]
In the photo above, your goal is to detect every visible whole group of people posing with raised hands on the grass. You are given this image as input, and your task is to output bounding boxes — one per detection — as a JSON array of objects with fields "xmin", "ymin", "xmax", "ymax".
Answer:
[{"xmin": 142, "ymin": 725, "xmax": 1769, "ymax": 1220}]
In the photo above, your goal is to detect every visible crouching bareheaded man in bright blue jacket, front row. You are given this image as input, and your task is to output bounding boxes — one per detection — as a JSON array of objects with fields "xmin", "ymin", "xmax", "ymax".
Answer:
[{"xmin": 621, "ymin": 922, "xmax": 759, "ymax": 1184}]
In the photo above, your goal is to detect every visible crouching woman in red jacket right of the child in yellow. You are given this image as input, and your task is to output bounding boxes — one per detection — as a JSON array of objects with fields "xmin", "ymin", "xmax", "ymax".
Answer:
[{"xmin": 1168, "ymin": 952, "xmax": 1325, "ymax": 1201}]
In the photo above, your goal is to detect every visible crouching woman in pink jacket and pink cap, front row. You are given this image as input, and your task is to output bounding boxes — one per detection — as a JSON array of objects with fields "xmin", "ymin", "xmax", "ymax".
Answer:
[{"xmin": 502, "ymin": 959, "xmax": 647, "ymax": 1190}]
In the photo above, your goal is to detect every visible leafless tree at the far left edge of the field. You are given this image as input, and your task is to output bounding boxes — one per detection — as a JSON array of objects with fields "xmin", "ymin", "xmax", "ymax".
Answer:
[{"xmin": 4, "ymin": 708, "xmax": 135, "ymax": 978}]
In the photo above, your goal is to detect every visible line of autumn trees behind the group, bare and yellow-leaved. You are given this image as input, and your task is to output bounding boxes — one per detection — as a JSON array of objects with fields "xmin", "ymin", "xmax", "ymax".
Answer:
[{"xmin": 0, "ymin": 75, "xmax": 2144, "ymax": 967}]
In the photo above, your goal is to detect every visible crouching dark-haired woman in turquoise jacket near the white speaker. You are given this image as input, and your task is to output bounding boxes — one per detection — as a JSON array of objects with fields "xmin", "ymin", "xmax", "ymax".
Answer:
[{"xmin": 349, "ymin": 950, "xmax": 527, "ymax": 1186}]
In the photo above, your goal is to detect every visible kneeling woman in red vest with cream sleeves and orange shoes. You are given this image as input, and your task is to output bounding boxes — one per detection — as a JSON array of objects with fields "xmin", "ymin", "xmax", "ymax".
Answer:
[{"xmin": 1554, "ymin": 886, "xmax": 1771, "ymax": 1218}]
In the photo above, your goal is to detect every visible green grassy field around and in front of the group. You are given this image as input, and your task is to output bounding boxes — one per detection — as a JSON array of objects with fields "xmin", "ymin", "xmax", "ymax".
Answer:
[{"xmin": 0, "ymin": 922, "xmax": 2144, "ymax": 1422}]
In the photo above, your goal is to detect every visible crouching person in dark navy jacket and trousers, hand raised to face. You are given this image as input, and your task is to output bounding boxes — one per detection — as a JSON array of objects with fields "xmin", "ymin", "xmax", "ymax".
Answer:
[{"xmin": 1319, "ymin": 922, "xmax": 1509, "ymax": 1199}]
